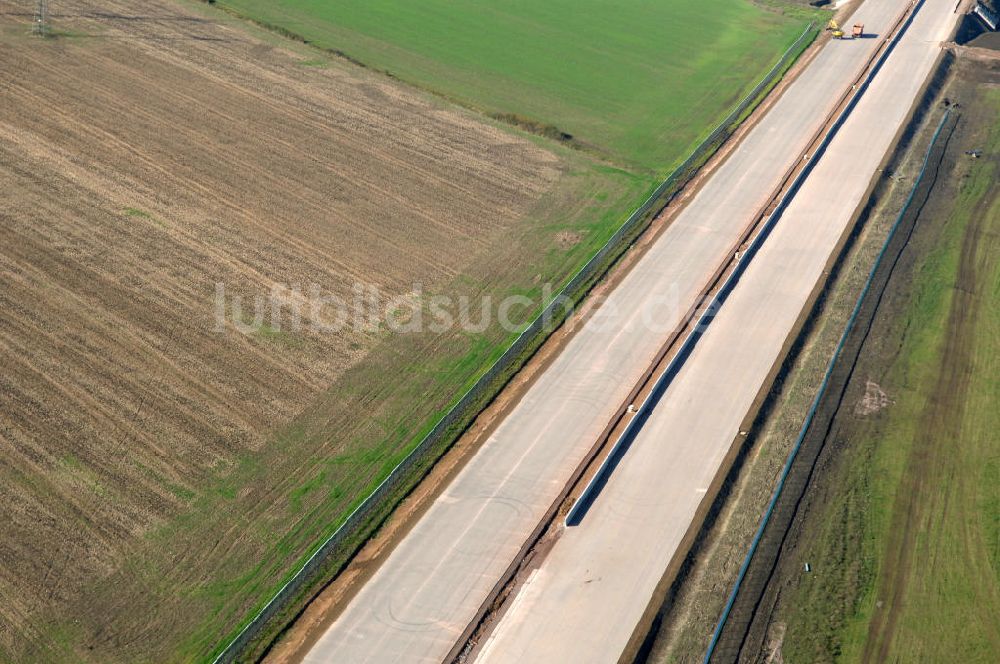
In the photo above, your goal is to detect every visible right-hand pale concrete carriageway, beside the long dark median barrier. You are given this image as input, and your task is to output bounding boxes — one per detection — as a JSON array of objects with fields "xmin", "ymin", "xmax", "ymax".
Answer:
[{"xmin": 477, "ymin": 0, "xmax": 957, "ymax": 664}]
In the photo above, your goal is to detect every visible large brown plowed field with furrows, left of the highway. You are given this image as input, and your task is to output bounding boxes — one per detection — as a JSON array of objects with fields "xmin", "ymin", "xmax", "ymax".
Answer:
[{"xmin": 0, "ymin": 0, "xmax": 643, "ymax": 661}]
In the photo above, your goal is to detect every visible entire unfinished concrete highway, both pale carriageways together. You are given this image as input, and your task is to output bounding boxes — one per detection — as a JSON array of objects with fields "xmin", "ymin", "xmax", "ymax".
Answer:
[{"xmin": 306, "ymin": 0, "xmax": 958, "ymax": 663}]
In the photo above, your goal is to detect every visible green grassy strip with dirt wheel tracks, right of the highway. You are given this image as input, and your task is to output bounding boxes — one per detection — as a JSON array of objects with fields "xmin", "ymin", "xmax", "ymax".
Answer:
[{"xmin": 774, "ymin": 76, "xmax": 1000, "ymax": 662}]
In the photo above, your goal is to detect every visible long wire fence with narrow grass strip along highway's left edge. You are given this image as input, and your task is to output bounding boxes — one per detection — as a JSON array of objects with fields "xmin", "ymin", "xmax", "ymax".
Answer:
[{"xmin": 212, "ymin": 22, "xmax": 818, "ymax": 664}]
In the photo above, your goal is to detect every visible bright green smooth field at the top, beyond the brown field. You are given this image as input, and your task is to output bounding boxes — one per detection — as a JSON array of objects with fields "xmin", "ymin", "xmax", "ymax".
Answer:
[{"xmin": 218, "ymin": 0, "xmax": 805, "ymax": 174}]
